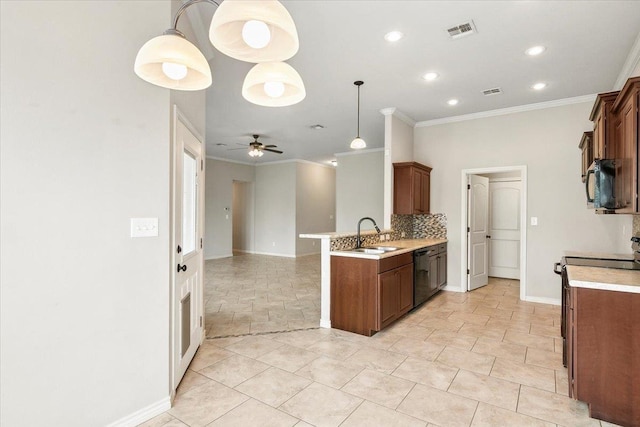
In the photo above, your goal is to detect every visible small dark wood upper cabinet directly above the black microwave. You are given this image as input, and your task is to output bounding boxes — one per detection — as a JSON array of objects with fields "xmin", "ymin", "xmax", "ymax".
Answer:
[{"xmin": 589, "ymin": 92, "xmax": 619, "ymax": 159}]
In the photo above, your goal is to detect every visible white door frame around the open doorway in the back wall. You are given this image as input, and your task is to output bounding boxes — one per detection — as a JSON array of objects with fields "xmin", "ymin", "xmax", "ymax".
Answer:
[{"xmin": 460, "ymin": 165, "xmax": 527, "ymax": 300}]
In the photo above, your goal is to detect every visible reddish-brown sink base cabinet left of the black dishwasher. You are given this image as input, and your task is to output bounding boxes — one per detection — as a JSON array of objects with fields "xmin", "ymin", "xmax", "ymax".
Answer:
[{"xmin": 331, "ymin": 252, "xmax": 413, "ymax": 336}]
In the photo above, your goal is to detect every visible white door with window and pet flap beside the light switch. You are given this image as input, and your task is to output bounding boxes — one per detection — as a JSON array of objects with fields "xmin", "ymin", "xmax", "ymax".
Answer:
[{"xmin": 172, "ymin": 109, "xmax": 204, "ymax": 391}]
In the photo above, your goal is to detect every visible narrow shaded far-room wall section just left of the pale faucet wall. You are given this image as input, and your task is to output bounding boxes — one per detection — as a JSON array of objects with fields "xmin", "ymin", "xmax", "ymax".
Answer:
[{"xmin": 296, "ymin": 162, "xmax": 336, "ymax": 256}]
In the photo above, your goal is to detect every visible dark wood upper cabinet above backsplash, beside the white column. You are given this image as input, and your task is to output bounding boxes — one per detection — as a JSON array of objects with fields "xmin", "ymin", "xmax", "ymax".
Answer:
[{"xmin": 393, "ymin": 162, "xmax": 431, "ymax": 215}]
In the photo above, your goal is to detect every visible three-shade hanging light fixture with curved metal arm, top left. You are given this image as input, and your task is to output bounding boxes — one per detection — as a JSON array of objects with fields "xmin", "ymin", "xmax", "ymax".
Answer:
[{"xmin": 134, "ymin": 0, "xmax": 306, "ymax": 107}]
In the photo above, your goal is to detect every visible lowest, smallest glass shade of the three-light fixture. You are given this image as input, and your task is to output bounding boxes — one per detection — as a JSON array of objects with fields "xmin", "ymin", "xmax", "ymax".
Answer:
[{"xmin": 244, "ymin": 62, "xmax": 307, "ymax": 107}]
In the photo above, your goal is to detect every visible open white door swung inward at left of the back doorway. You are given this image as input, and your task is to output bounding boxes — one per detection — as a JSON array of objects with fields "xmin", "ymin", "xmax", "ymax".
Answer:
[{"xmin": 467, "ymin": 175, "xmax": 489, "ymax": 291}]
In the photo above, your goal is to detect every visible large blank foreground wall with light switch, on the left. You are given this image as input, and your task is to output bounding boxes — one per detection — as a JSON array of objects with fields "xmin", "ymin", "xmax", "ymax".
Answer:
[{"xmin": 0, "ymin": 1, "xmax": 182, "ymax": 427}]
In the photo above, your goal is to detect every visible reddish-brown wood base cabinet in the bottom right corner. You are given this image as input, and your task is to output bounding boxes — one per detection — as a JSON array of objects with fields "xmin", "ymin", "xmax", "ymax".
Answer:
[{"xmin": 567, "ymin": 287, "xmax": 640, "ymax": 426}]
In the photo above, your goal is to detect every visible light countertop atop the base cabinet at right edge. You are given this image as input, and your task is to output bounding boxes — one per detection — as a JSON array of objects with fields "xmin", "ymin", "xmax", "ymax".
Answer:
[{"xmin": 567, "ymin": 265, "xmax": 640, "ymax": 294}]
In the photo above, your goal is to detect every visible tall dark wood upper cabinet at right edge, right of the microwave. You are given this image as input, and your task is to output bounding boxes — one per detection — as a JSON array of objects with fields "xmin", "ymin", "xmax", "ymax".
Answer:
[{"xmin": 613, "ymin": 77, "xmax": 640, "ymax": 213}]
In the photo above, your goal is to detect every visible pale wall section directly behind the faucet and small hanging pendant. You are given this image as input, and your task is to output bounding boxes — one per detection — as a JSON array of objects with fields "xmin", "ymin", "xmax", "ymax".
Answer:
[{"xmin": 336, "ymin": 150, "xmax": 384, "ymax": 232}]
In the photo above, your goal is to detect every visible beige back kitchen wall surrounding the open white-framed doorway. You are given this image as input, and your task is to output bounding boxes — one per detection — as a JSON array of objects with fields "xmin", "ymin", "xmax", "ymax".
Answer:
[{"xmin": 414, "ymin": 103, "xmax": 631, "ymax": 299}]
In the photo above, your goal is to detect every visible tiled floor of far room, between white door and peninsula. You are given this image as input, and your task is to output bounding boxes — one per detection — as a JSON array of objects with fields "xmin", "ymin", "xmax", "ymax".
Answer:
[{"xmin": 204, "ymin": 254, "xmax": 320, "ymax": 338}]
